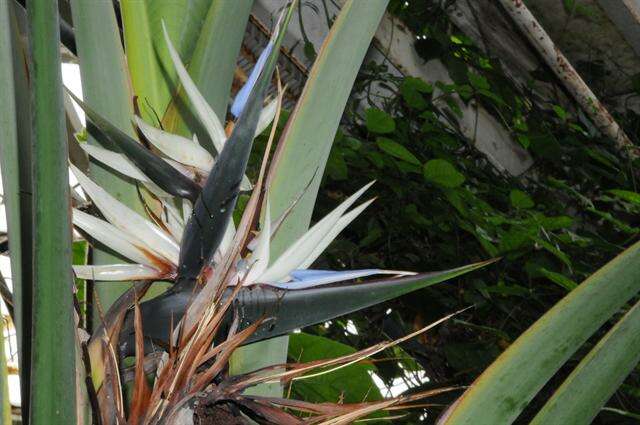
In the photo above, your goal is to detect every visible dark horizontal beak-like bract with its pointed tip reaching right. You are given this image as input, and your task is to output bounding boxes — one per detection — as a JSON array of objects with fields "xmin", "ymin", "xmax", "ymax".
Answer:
[{"xmin": 120, "ymin": 260, "xmax": 493, "ymax": 356}]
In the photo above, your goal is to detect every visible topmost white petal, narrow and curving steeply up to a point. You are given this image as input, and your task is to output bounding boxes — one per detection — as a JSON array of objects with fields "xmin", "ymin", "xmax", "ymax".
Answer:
[{"xmin": 162, "ymin": 21, "xmax": 227, "ymax": 153}]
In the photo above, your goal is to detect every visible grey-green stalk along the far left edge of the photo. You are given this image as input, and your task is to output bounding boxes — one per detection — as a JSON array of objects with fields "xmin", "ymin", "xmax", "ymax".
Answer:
[{"xmin": 0, "ymin": 2, "xmax": 33, "ymax": 410}]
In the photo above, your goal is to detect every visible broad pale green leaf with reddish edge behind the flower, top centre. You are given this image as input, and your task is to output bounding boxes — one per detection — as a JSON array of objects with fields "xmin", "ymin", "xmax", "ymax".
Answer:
[{"xmin": 230, "ymin": 0, "xmax": 388, "ymax": 394}]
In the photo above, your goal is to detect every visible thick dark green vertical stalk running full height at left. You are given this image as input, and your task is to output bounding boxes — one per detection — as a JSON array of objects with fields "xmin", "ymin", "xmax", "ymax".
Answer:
[{"xmin": 25, "ymin": 0, "xmax": 76, "ymax": 425}]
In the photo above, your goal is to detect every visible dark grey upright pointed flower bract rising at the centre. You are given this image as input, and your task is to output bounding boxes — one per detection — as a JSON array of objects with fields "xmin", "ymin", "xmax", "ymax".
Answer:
[{"xmin": 176, "ymin": 3, "xmax": 293, "ymax": 286}]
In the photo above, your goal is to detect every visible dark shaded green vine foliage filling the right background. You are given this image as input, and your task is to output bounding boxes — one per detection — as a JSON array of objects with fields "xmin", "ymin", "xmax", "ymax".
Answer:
[{"xmin": 248, "ymin": 1, "xmax": 640, "ymax": 423}]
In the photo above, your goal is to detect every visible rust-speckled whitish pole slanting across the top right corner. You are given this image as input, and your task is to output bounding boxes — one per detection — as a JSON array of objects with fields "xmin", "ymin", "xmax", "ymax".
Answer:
[{"xmin": 500, "ymin": 0, "xmax": 640, "ymax": 158}]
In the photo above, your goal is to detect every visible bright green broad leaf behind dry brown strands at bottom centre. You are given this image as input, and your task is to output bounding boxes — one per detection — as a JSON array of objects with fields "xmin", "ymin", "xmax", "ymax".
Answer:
[{"xmin": 289, "ymin": 333, "xmax": 382, "ymax": 403}]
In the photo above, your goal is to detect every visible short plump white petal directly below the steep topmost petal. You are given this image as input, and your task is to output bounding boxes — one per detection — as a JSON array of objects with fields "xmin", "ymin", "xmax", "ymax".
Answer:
[{"xmin": 134, "ymin": 116, "xmax": 213, "ymax": 173}]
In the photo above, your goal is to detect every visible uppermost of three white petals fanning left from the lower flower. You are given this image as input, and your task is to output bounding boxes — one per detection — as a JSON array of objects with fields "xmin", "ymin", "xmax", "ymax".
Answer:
[{"xmin": 70, "ymin": 165, "xmax": 180, "ymax": 264}]
